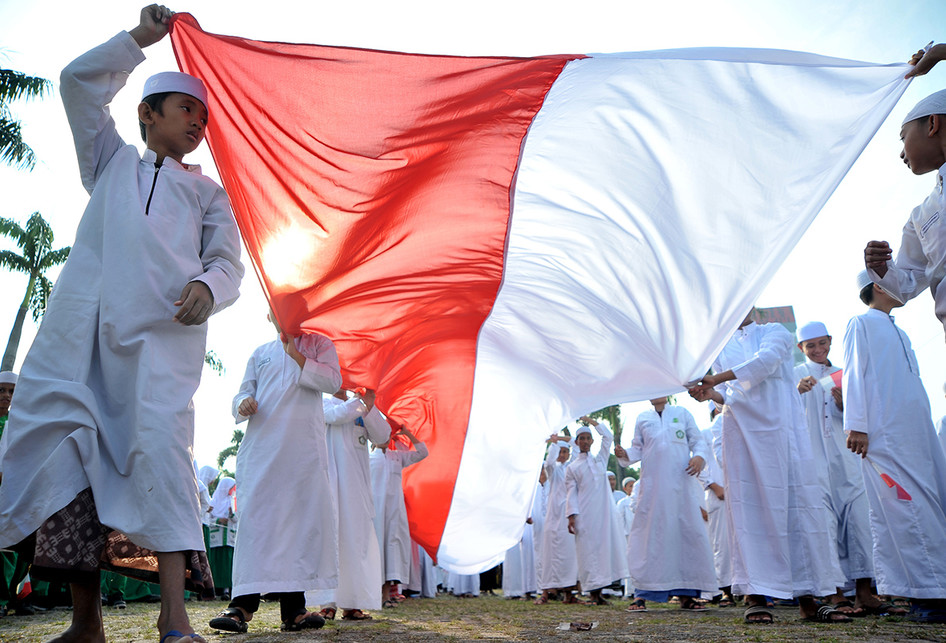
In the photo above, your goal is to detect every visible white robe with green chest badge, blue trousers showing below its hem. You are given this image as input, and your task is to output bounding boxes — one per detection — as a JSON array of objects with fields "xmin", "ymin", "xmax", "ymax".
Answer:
[{"xmin": 619, "ymin": 405, "xmax": 718, "ymax": 593}]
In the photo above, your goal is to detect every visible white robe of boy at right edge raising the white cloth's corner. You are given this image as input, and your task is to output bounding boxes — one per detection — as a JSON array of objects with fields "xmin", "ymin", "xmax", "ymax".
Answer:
[{"xmin": 868, "ymin": 164, "xmax": 946, "ymax": 338}]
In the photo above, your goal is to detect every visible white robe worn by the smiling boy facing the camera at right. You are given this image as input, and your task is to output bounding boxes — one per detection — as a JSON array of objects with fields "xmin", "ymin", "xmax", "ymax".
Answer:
[{"xmin": 795, "ymin": 359, "xmax": 874, "ymax": 588}]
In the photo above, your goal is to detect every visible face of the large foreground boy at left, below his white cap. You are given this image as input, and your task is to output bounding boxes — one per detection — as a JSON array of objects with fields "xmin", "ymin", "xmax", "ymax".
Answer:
[{"xmin": 139, "ymin": 93, "xmax": 207, "ymax": 162}]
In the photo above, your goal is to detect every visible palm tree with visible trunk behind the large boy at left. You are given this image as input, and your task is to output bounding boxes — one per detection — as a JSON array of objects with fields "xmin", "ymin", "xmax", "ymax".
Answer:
[{"xmin": 0, "ymin": 212, "xmax": 71, "ymax": 371}]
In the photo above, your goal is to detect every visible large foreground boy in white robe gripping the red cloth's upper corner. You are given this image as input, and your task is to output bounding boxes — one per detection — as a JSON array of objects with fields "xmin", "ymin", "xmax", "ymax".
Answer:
[{"xmin": 0, "ymin": 5, "xmax": 243, "ymax": 643}]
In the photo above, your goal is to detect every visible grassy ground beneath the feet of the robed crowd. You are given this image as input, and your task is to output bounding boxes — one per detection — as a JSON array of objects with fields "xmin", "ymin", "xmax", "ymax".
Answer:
[{"xmin": 0, "ymin": 596, "xmax": 946, "ymax": 643}]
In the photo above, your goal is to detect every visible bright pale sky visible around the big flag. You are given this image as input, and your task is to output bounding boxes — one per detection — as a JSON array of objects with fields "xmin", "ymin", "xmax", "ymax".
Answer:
[{"xmin": 0, "ymin": 0, "xmax": 946, "ymax": 464}]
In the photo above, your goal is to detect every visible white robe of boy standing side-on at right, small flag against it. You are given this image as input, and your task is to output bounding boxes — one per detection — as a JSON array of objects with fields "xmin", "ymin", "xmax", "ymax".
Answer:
[{"xmin": 843, "ymin": 309, "xmax": 946, "ymax": 599}]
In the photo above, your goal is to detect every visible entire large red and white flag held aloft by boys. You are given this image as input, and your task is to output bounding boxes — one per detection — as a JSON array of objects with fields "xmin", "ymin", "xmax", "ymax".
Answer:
[{"xmin": 171, "ymin": 14, "xmax": 907, "ymax": 573}]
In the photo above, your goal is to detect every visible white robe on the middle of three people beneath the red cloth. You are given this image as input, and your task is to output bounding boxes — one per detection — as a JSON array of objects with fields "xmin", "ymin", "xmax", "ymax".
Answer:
[{"xmin": 316, "ymin": 397, "xmax": 391, "ymax": 610}]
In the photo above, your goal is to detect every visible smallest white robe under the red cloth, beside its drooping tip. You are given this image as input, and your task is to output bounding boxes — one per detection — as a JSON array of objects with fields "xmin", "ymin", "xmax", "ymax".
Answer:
[{"xmin": 369, "ymin": 442, "xmax": 427, "ymax": 583}]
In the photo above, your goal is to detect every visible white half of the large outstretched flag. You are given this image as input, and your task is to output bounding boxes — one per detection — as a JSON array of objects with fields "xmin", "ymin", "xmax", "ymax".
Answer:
[{"xmin": 439, "ymin": 49, "xmax": 908, "ymax": 572}]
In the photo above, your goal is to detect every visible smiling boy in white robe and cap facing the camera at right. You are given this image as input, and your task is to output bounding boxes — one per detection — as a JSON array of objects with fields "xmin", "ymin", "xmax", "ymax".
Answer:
[{"xmin": 795, "ymin": 322, "xmax": 906, "ymax": 616}]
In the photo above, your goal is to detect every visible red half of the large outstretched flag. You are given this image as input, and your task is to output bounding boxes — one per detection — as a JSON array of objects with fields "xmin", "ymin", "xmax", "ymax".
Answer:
[{"xmin": 171, "ymin": 14, "xmax": 576, "ymax": 556}]
